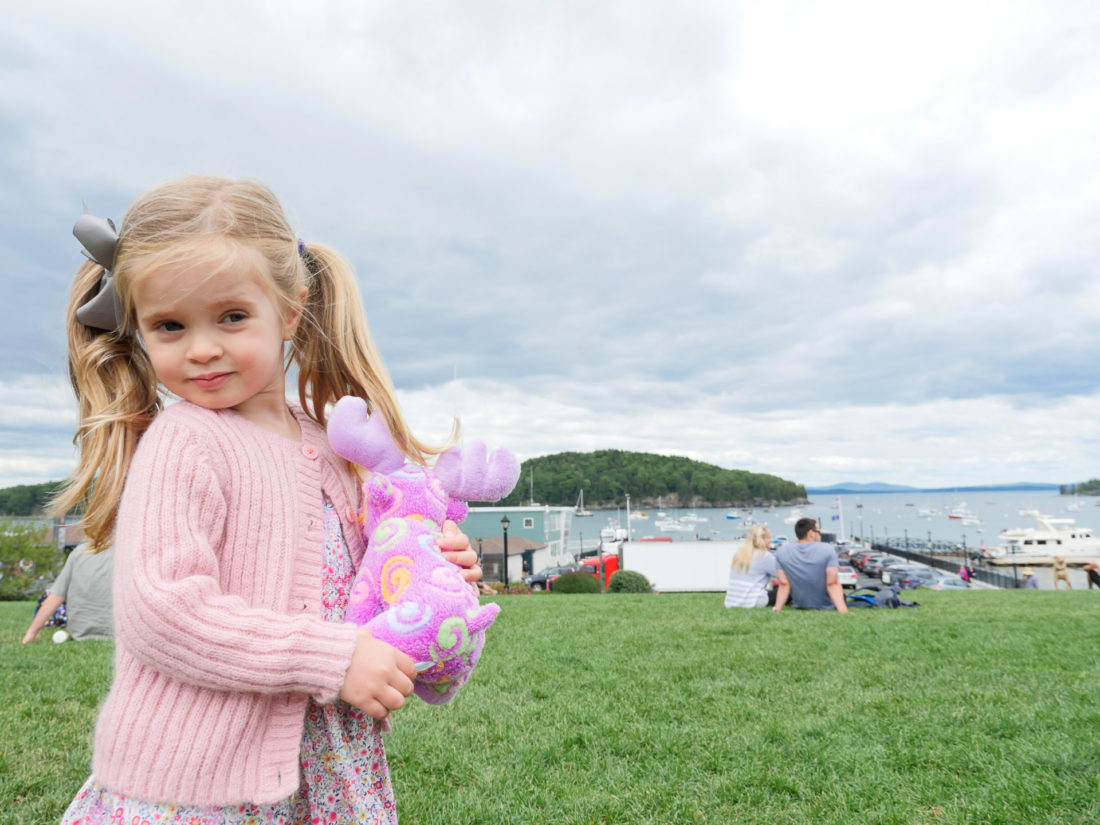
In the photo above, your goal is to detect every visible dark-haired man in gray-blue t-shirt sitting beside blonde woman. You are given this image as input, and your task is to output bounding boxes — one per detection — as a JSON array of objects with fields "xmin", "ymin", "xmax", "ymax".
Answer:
[{"xmin": 774, "ymin": 518, "xmax": 848, "ymax": 613}]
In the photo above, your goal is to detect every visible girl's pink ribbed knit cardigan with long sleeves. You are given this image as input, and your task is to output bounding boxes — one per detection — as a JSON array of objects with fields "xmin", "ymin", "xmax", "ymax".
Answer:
[{"xmin": 92, "ymin": 402, "xmax": 363, "ymax": 805}]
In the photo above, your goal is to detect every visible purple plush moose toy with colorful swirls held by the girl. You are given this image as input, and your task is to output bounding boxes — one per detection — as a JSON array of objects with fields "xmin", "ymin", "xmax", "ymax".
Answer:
[{"xmin": 328, "ymin": 396, "xmax": 519, "ymax": 705}]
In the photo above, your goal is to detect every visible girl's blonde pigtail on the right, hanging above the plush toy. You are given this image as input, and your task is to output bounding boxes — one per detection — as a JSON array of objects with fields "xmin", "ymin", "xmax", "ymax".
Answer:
[{"xmin": 293, "ymin": 243, "xmax": 458, "ymax": 463}]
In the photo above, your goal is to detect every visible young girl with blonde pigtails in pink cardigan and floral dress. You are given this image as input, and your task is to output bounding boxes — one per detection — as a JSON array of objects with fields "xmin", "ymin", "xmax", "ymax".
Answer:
[{"xmin": 56, "ymin": 177, "xmax": 481, "ymax": 825}]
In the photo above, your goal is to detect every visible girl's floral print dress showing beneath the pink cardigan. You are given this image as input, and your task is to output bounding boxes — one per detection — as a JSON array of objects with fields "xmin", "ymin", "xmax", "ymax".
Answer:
[{"xmin": 62, "ymin": 499, "xmax": 397, "ymax": 825}]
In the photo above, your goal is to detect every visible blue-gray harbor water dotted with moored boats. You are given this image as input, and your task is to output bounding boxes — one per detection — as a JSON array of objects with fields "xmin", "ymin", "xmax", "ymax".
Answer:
[{"xmin": 570, "ymin": 490, "xmax": 1100, "ymax": 590}]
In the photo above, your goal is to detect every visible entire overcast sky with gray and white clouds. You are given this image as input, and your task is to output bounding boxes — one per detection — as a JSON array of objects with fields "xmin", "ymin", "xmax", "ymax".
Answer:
[{"xmin": 0, "ymin": 0, "xmax": 1100, "ymax": 492}]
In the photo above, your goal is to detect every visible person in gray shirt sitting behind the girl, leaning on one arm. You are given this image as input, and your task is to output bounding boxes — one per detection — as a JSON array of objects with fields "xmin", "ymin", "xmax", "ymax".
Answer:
[{"xmin": 23, "ymin": 545, "xmax": 114, "ymax": 645}]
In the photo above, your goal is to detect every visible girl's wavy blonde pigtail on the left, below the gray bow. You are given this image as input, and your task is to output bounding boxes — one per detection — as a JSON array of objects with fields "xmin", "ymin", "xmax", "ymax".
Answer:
[{"xmin": 50, "ymin": 262, "xmax": 161, "ymax": 552}]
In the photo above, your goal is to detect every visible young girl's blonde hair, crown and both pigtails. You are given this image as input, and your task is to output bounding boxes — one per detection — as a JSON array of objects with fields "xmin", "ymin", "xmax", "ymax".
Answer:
[{"xmin": 52, "ymin": 176, "xmax": 446, "ymax": 551}]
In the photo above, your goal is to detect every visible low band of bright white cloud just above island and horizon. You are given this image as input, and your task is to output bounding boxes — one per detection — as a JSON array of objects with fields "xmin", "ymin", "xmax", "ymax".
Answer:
[{"xmin": 400, "ymin": 380, "xmax": 1100, "ymax": 486}]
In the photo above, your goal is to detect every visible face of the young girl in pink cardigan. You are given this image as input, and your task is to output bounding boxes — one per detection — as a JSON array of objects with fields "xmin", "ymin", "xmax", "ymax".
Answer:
[{"xmin": 131, "ymin": 245, "xmax": 300, "ymax": 422}]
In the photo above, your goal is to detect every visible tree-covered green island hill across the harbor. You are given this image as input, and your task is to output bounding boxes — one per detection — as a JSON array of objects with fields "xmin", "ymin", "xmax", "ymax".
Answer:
[{"xmin": 499, "ymin": 450, "xmax": 806, "ymax": 508}]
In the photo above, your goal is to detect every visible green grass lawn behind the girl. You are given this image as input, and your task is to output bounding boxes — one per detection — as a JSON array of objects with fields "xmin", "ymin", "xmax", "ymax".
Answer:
[{"xmin": 0, "ymin": 591, "xmax": 1100, "ymax": 825}]
